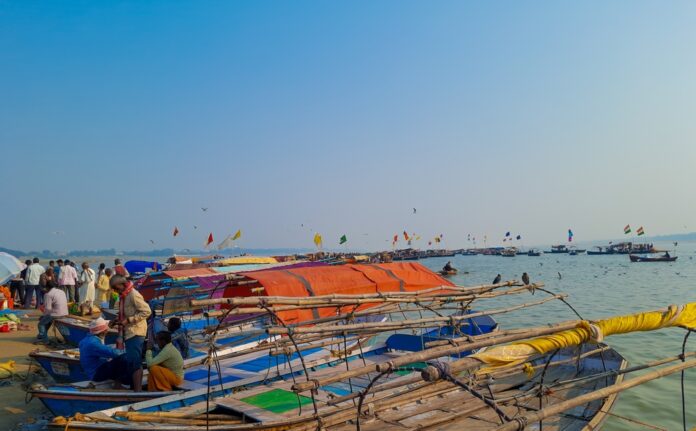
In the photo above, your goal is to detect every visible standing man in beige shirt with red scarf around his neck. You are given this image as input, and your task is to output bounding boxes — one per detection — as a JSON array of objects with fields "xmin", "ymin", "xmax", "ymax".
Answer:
[{"xmin": 109, "ymin": 274, "xmax": 152, "ymax": 391}]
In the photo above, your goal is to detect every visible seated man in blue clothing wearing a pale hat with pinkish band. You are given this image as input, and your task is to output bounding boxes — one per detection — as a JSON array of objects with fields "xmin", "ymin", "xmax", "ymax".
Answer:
[{"xmin": 79, "ymin": 317, "xmax": 140, "ymax": 387}]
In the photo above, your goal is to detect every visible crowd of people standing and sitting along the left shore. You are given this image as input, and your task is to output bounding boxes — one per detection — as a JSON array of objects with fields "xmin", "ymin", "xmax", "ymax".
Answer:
[{"xmin": 10, "ymin": 258, "xmax": 189, "ymax": 391}]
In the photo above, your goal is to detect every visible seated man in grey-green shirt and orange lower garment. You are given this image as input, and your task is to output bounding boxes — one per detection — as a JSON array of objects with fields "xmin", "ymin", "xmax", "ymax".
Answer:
[{"xmin": 145, "ymin": 331, "xmax": 184, "ymax": 391}]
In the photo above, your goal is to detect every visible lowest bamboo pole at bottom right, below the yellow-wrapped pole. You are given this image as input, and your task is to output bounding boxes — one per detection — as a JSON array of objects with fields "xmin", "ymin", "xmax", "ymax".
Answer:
[{"xmin": 495, "ymin": 359, "xmax": 696, "ymax": 431}]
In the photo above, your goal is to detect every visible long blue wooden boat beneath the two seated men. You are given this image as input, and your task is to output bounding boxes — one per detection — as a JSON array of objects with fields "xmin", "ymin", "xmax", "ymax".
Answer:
[{"xmin": 29, "ymin": 316, "xmax": 497, "ymax": 417}]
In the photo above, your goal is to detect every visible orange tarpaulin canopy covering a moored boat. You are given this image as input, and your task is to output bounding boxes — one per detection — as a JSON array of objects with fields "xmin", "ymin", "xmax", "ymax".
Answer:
[{"xmin": 225, "ymin": 262, "xmax": 454, "ymax": 323}]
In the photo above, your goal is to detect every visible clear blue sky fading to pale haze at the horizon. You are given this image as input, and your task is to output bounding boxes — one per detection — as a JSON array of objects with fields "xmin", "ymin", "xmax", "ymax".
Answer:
[{"xmin": 0, "ymin": 0, "xmax": 696, "ymax": 250}]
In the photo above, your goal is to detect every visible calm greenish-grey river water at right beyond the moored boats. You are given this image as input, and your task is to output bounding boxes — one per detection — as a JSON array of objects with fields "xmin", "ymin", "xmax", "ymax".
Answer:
[{"xmin": 420, "ymin": 243, "xmax": 696, "ymax": 431}]
